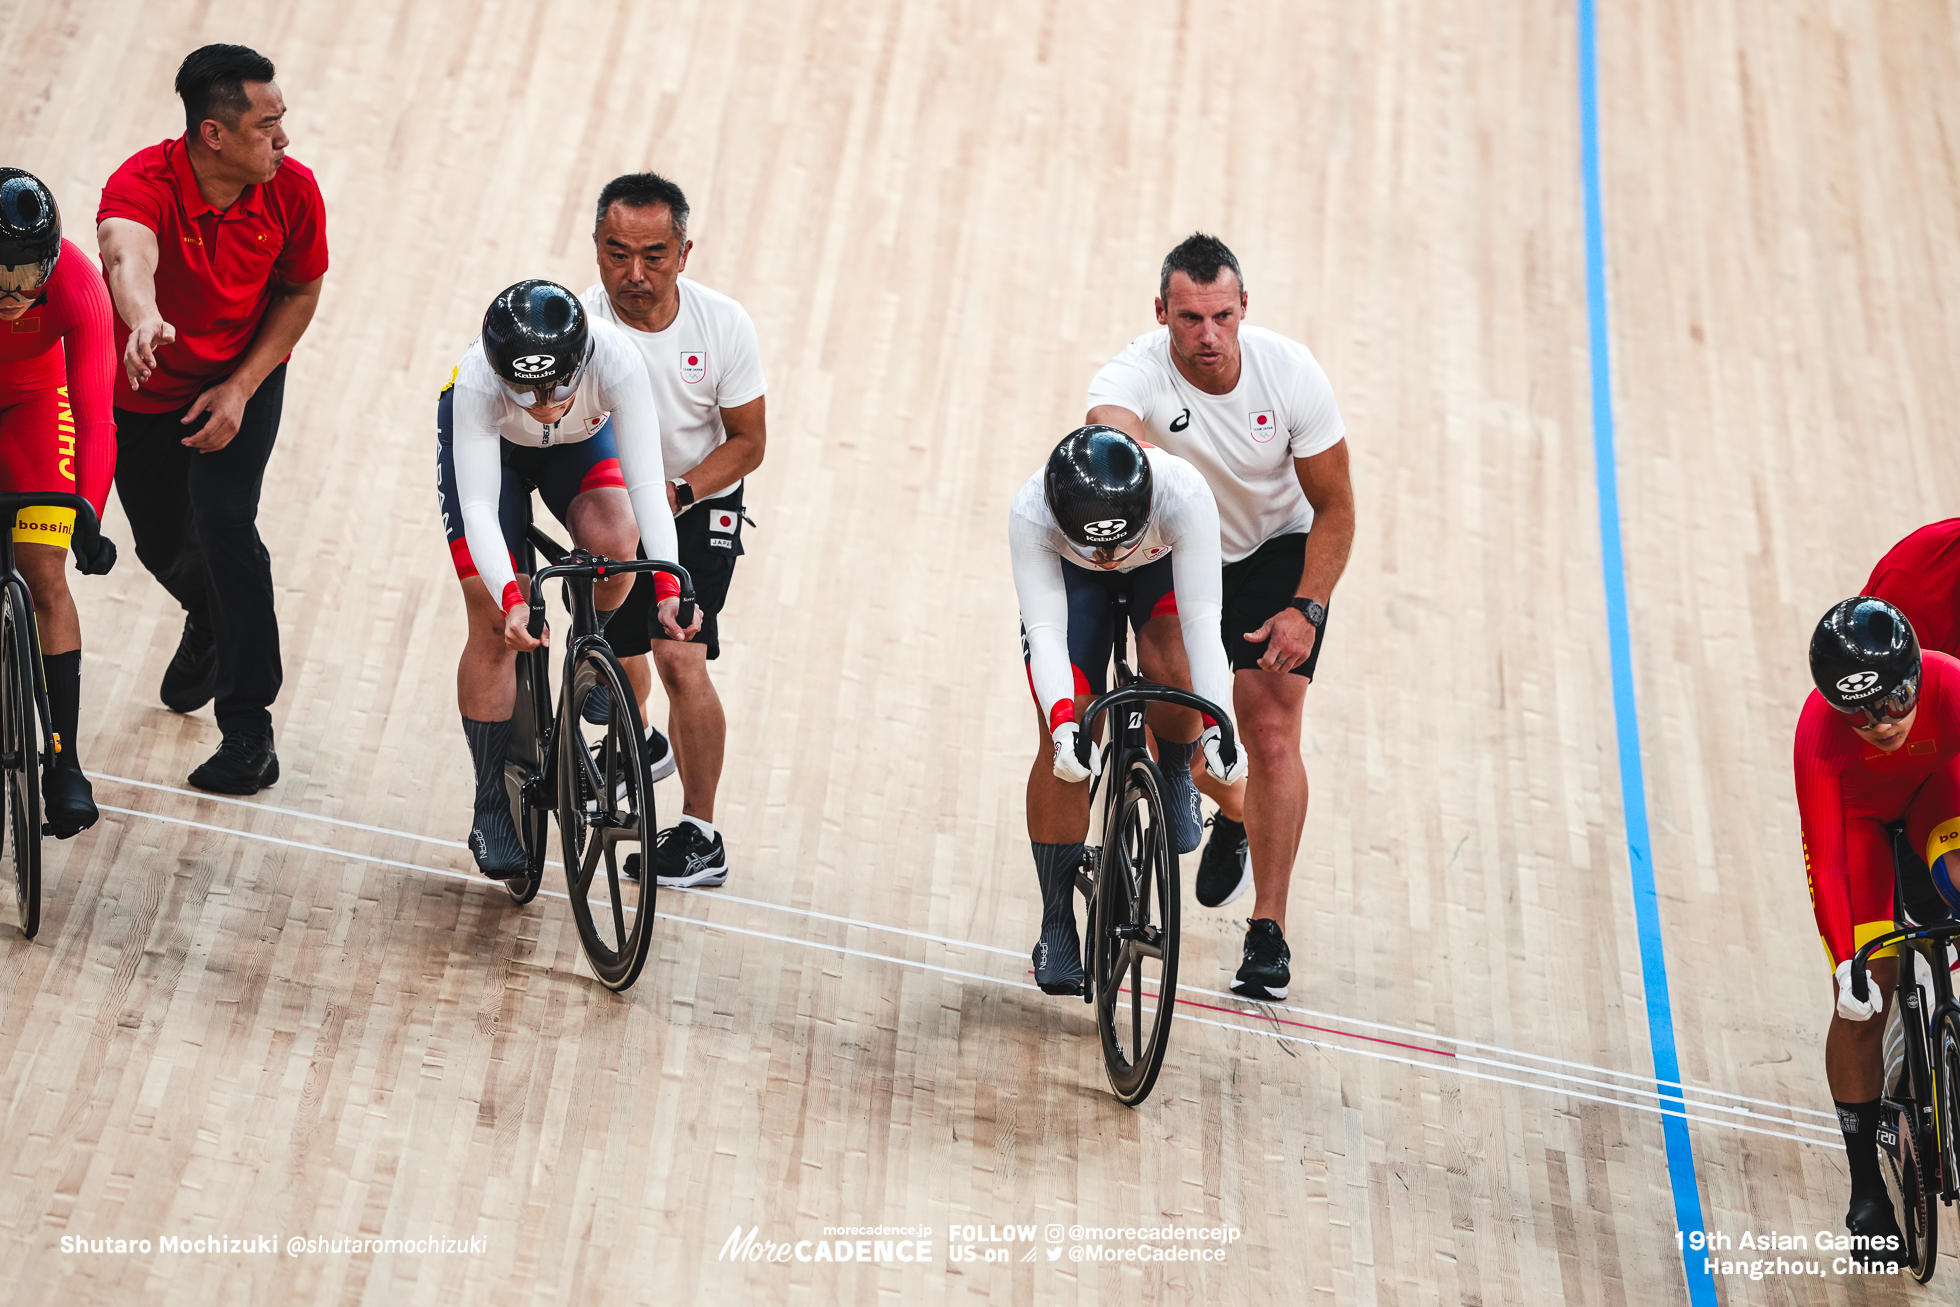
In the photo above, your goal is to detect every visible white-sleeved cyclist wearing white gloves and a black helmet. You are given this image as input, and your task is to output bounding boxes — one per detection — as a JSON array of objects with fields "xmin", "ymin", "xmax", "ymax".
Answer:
[{"xmin": 1007, "ymin": 427, "xmax": 1245, "ymax": 993}]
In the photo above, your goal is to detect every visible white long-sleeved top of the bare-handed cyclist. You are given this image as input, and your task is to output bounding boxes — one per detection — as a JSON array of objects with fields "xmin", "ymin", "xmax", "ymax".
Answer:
[{"xmin": 451, "ymin": 321, "xmax": 680, "ymax": 604}]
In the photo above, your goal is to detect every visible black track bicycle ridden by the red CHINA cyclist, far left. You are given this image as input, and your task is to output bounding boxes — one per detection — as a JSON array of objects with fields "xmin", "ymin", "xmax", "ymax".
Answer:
[{"xmin": 0, "ymin": 492, "xmax": 114, "ymax": 939}]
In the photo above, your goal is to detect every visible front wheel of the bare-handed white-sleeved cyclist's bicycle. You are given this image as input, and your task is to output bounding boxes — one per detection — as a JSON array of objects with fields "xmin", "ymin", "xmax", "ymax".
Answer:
[{"xmin": 557, "ymin": 645, "xmax": 655, "ymax": 990}]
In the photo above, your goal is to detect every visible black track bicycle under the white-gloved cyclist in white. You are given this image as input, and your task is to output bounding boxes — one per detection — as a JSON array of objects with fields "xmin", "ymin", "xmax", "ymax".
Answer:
[{"xmin": 1076, "ymin": 594, "xmax": 1239, "ymax": 1107}]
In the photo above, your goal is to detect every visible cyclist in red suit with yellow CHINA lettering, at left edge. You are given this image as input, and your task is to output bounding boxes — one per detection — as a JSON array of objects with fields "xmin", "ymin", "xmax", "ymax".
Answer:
[{"xmin": 0, "ymin": 169, "xmax": 116, "ymax": 839}]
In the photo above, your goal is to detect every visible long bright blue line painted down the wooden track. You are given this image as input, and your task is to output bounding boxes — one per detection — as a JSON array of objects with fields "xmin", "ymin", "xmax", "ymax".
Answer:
[{"xmin": 1578, "ymin": 0, "xmax": 1717, "ymax": 1307}]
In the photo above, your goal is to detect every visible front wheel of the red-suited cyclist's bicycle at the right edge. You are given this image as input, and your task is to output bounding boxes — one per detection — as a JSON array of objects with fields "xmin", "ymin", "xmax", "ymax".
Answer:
[{"xmin": 1878, "ymin": 968, "xmax": 1940, "ymax": 1283}]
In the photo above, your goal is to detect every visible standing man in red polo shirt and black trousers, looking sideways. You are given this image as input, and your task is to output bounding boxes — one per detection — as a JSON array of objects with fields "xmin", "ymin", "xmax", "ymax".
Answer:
[{"xmin": 96, "ymin": 45, "xmax": 327, "ymax": 794}]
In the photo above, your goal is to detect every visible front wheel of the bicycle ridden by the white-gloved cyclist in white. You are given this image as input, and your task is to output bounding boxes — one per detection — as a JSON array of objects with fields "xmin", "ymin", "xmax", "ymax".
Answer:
[{"xmin": 1096, "ymin": 756, "xmax": 1178, "ymax": 1107}]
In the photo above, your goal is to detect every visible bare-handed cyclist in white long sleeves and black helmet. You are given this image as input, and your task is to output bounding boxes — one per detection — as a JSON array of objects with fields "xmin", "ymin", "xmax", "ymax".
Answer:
[{"xmin": 435, "ymin": 282, "xmax": 700, "ymax": 878}]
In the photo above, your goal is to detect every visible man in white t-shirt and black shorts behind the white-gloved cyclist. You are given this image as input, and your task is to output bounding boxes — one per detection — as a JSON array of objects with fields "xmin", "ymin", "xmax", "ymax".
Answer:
[{"xmin": 1088, "ymin": 233, "xmax": 1354, "ymax": 999}]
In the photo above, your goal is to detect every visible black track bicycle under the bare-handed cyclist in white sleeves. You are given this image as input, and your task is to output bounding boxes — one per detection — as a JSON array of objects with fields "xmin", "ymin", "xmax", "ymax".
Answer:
[{"xmin": 490, "ymin": 519, "xmax": 694, "ymax": 992}]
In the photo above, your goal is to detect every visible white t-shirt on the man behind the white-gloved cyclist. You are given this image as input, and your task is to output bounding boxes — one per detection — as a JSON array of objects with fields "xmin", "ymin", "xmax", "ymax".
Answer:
[{"xmin": 1090, "ymin": 325, "xmax": 1347, "ymax": 562}]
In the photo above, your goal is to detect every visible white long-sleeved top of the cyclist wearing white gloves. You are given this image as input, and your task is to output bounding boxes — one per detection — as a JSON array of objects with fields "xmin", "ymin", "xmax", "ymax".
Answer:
[{"xmin": 1007, "ymin": 449, "xmax": 1231, "ymax": 727}]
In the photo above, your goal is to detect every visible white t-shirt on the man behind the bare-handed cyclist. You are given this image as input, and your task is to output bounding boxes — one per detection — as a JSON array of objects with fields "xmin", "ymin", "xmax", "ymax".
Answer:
[{"xmin": 578, "ymin": 276, "xmax": 768, "ymax": 500}]
